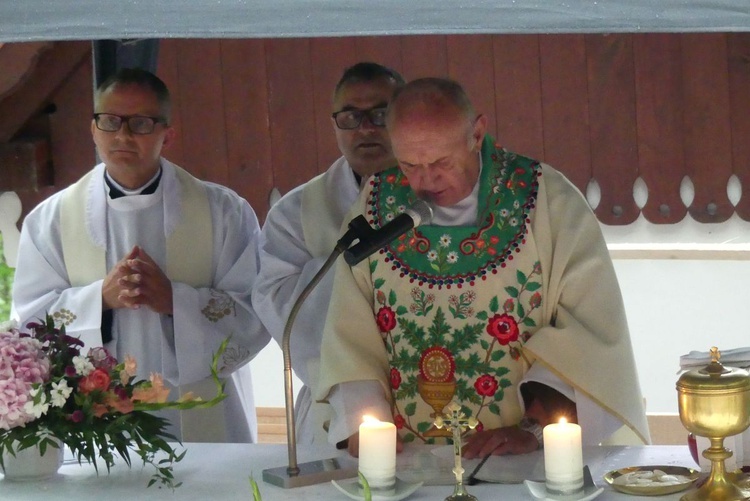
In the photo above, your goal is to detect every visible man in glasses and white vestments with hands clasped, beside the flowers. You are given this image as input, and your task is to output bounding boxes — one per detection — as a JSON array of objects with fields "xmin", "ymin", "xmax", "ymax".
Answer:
[{"xmin": 13, "ymin": 69, "xmax": 270, "ymax": 442}]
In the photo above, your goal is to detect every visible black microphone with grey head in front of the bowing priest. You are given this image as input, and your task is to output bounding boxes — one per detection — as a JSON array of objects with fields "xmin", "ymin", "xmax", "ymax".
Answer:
[{"xmin": 344, "ymin": 200, "xmax": 432, "ymax": 266}]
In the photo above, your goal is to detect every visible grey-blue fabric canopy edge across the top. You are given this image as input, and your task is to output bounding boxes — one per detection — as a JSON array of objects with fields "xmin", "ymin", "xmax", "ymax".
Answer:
[{"xmin": 0, "ymin": 0, "xmax": 750, "ymax": 42}]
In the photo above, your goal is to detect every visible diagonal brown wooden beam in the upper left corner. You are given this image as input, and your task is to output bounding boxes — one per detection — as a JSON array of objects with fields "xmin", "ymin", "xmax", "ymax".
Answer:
[{"xmin": 0, "ymin": 42, "xmax": 93, "ymax": 143}]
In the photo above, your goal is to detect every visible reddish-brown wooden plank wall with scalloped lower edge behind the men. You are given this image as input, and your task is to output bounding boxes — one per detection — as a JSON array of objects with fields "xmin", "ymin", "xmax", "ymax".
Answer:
[{"xmin": 159, "ymin": 33, "xmax": 750, "ymax": 224}]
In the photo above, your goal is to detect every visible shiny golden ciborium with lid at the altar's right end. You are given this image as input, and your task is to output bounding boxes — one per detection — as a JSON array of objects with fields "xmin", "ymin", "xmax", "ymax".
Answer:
[{"xmin": 677, "ymin": 347, "xmax": 750, "ymax": 501}]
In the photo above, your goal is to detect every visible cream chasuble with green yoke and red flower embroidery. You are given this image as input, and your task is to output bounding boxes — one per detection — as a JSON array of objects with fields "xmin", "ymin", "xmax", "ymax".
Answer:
[{"xmin": 317, "ymin": 137, "xmax": 648, "ymax": 443}]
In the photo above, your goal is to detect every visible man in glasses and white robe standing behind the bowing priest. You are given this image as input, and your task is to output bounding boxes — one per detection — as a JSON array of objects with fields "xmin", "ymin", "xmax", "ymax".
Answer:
[{"xmin": 253, "ymin": 62, "xmax": 404, "ymax": 444}]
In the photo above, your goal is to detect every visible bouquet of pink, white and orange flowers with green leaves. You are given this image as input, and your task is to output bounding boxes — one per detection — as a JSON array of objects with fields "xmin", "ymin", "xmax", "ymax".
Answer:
[{"xmin": 0, "ymin": 315, "xmax": 228, "ymax": 489}]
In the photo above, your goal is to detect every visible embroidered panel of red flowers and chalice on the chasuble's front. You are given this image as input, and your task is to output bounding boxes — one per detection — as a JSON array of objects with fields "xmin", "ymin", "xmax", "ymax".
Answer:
[{"xmin": 372, "ymin": 261, "xmax": 541, "ymax": 443}]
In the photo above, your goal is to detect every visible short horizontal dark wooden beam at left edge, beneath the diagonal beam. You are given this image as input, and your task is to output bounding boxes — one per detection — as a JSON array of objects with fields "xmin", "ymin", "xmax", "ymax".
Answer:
[{"xmin": 0, "ymin": 140, "xmax": 52, "ymax": 191}]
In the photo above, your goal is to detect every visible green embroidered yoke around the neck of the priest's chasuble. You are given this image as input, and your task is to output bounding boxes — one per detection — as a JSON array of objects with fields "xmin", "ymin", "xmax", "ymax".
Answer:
[{"xmin": 368, "ymin": 137, "xmax": 540, "ymax": 289}]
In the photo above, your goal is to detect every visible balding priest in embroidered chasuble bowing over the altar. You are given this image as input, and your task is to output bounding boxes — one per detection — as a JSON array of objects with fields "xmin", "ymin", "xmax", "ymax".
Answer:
[{"xmin": 317, "ymin": 79, "xmax": 649, "ymax": 453}]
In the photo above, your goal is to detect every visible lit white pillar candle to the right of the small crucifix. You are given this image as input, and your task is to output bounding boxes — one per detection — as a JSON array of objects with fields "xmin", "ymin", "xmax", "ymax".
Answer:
[{"xmin": 543, "ymin": 419, "xmax": 583, "ymax": 494}]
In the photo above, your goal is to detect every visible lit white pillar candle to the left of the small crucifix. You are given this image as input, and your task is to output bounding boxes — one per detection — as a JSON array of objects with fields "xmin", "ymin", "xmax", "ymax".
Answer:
[{"xmin": 359, "ymin": 416, "xmax": 396, "ymax": 489}]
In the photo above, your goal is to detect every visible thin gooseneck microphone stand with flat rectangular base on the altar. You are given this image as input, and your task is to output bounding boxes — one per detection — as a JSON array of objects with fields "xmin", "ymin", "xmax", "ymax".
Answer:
[{"xmin": 263, "ymin": 216, "xmax": 371, "ymax": 489}]
